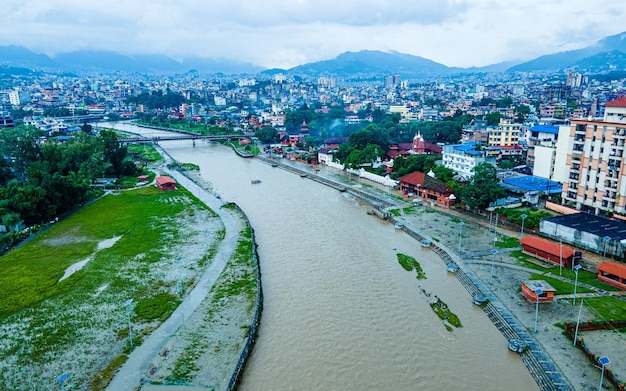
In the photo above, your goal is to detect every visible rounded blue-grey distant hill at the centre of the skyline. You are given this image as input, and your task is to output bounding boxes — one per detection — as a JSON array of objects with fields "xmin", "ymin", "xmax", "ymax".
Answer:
[{"xmin": 287, "ymin": 50, "xmax": 452, "ymax": 79}]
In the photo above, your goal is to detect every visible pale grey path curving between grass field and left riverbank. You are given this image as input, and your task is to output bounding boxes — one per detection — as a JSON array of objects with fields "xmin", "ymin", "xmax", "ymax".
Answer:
[{"xmin": 107, "ymin": 168, "xmax": 244, "ymax": 391}]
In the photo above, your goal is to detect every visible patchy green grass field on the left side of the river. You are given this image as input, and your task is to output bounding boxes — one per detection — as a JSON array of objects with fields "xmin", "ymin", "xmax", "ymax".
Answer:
[{"xmin": 0, "ymin": 187, "xmax": 224, "ymax": 390}]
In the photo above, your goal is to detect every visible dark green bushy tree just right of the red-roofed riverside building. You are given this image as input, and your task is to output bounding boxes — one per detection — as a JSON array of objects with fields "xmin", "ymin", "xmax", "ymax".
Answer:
[{"xmin": 461, "ymin": 163, "xmax": 506, "ymax": 209}]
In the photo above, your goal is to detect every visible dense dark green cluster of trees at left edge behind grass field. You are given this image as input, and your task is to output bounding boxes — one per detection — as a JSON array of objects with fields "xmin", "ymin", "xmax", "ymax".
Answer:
[{"xmin": 0, "ymin": 126, "xmax": 137, "ymax": 231}]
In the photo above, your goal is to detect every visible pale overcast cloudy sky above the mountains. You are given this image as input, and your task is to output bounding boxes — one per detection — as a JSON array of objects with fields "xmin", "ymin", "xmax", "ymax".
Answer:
[{"xmin": 0, "ymin": 0, "xmax": 626, "ymax": 68}]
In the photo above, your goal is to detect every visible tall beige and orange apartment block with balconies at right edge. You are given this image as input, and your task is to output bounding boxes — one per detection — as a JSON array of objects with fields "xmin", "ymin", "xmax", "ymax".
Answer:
[{"xmin": 562, "ymin": 97, "xmax": 626, "ymax": 214}]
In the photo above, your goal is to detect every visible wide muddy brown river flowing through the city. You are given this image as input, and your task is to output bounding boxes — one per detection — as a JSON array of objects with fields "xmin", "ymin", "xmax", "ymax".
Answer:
[{"xmin": 105, "ymin": 125, "xmax": 538, "ymax": 391}]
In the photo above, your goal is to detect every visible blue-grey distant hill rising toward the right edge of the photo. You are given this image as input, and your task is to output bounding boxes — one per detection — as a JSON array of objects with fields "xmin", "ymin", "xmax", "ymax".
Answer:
[{"xmin": 508, "ymin": 32, "xmax": 626, "ymax": 73}]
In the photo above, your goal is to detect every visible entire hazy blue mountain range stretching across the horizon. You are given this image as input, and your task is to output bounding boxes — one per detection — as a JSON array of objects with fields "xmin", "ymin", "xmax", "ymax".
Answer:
[{"xmin": 0, "ymin": 32, "xmax": 626, "ymax": 79}]
